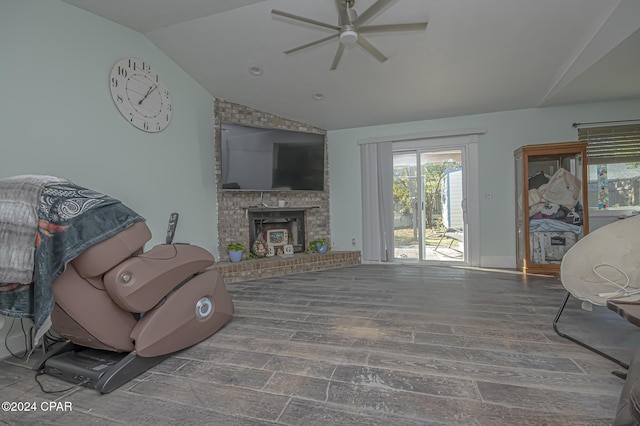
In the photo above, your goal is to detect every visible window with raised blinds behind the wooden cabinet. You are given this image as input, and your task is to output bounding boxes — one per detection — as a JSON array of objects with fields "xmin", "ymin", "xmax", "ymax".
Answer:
[{"xmin": 578, "ymin": 124, "xmax": 640, "ymax": 210}]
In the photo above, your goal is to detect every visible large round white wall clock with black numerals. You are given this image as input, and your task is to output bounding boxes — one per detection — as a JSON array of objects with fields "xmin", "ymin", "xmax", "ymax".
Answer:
[{"xmin": 109, "ymin": 58, "xmax": 172, "ymax": 133}]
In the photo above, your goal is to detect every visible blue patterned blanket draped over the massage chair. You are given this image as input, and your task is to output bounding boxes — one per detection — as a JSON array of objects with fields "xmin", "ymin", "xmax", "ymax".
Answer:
[{"xmin": 0, "ymin": 183, "xmax": 144, "ymax": 344}]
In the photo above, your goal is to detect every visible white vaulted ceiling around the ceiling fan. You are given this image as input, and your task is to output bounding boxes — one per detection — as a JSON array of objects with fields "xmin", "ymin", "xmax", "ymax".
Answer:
[{"xmin": 63, "ymin": 0, "xmax": 640, "ymax": 130}]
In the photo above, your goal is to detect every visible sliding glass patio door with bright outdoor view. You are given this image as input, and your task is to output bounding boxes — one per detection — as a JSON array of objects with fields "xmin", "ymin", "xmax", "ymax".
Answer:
[{"xmin": 393, "ymin": 148, "xmax": 467, "ymax": 263}]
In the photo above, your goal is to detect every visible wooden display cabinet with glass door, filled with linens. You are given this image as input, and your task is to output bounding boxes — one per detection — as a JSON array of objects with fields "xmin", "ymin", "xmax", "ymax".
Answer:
[{"xmin": 514, "ymin": 142, "xmax": 589, "ymax": 274}]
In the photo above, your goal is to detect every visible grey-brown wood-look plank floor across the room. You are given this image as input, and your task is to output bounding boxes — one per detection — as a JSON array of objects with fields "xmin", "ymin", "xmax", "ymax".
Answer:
[{"xmin": 0, "ymin": 265, "xmax": 640, "ymax": 426}]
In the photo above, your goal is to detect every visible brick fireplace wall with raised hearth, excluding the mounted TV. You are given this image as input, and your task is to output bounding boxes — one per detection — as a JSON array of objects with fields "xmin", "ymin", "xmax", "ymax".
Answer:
[{"xmin": 214, "ymin": 99, "xmax": 361, "ymax": 282}]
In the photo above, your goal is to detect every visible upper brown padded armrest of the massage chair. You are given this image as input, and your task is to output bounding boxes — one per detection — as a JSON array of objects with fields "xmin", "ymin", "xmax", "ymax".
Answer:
[{"xmin": 104, "ymin": 244, "xmax": 214, "ymax": 312}]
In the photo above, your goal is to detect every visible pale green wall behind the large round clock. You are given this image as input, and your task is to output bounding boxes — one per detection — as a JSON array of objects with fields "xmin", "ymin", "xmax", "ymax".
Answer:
[{"xmin": 0, "ymin": 0, "xmax": 218, "ymax": 355}]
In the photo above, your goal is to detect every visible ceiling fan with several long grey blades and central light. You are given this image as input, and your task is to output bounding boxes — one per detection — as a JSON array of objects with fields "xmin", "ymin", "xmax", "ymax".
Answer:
[{"xmin": 271, "ymin": 0, "xmax": 427, "ymax": 70}]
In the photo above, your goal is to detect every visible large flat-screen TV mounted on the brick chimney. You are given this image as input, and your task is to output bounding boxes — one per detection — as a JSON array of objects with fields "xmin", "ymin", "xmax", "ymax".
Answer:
[{"xmin": 220, "ymin": 123, "xmax": 325, "ymax": 191}]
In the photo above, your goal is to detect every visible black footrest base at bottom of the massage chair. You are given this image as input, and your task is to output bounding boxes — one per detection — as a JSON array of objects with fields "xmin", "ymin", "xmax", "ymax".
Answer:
[{"xmin": 44, "ymin": 344, "xmax": 171, "ymax": 394}]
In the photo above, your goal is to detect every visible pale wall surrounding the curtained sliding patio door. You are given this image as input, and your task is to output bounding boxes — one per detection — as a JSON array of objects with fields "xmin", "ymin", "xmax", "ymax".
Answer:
[{"xmin": 327, "ymin": 99, "xmax": 640, "ymax": 268}]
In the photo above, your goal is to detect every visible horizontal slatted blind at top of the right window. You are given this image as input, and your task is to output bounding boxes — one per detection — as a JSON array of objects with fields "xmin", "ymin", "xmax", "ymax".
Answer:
[{"xmin": 578, "ymin": 124, "xmax": 640, "ymax": 164}]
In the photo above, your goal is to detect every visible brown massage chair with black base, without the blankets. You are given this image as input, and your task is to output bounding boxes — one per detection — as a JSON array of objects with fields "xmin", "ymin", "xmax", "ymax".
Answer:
[{"xmin": 35, "ymin": 222, "xmax": 233, "ymax": 393}]
